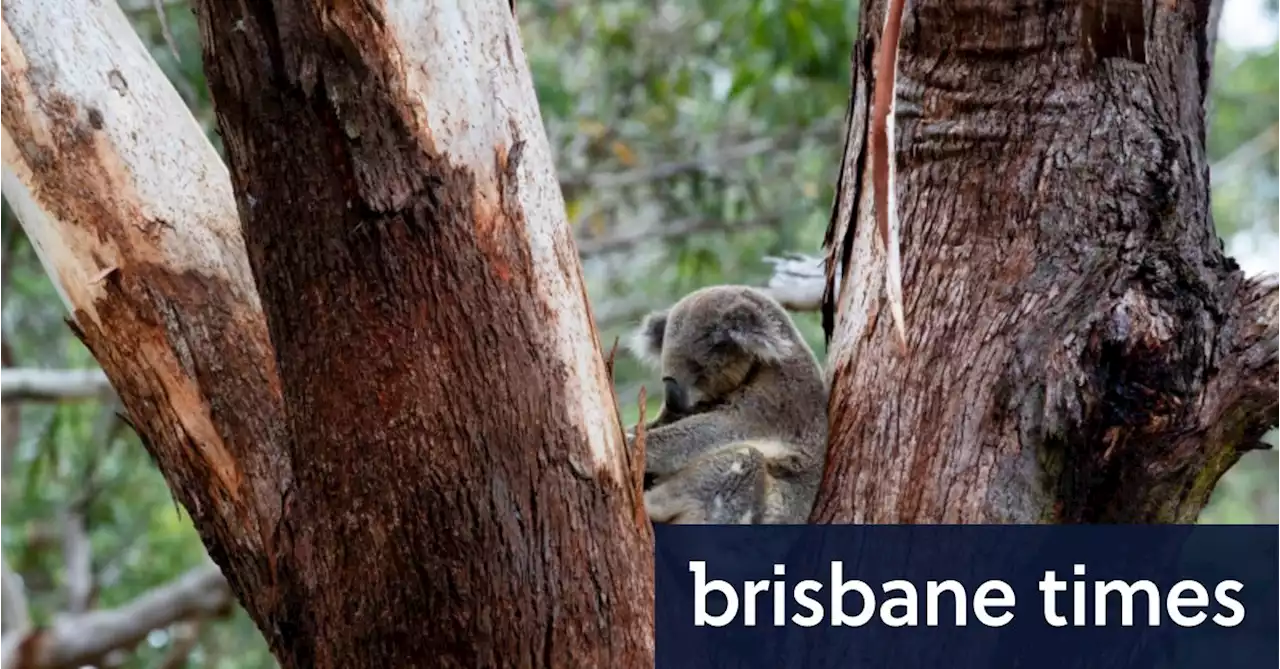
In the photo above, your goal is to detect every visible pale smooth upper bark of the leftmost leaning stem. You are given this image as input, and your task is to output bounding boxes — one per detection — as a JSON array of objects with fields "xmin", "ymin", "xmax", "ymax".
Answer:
[{"xmin": 0, "ymin": 0, "xmax": 257, "ymax": 320}]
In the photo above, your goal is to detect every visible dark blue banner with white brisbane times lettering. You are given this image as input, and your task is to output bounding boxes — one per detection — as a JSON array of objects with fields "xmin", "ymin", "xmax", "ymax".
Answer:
[{"xmin": 654, "ymin": 526, "xmax": 1280, "ymax": 669}]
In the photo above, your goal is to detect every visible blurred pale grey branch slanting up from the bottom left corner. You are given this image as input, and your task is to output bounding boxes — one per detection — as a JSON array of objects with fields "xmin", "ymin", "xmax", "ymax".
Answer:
[{"xmin": 0, "ymin": 565, "xmax": 232, "ymax": 669}]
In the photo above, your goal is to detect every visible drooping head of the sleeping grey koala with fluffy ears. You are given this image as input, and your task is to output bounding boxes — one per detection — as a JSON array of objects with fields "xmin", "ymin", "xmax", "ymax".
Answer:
[{"xmin": 630, "ymin": 285, "xmax": 808, "ymax": 411}]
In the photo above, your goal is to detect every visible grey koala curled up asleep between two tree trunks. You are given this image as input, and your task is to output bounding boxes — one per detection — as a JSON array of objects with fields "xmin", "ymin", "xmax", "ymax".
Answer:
[{"xmin": 628, "ymin": 285, "xmax": 827, "ymax": 524}]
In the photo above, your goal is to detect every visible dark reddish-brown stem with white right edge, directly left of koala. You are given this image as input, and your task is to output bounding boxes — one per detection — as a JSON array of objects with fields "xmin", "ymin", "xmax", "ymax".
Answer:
[{"xmin": 197, "ymin": 0, "xmax": 653, "ymax": 668}]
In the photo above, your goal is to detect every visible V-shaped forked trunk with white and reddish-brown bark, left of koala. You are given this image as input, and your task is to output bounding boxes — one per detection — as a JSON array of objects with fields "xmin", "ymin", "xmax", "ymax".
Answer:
[{"xmin": 0, "ymin": 0, "xmax": 653, "ymax": 668}]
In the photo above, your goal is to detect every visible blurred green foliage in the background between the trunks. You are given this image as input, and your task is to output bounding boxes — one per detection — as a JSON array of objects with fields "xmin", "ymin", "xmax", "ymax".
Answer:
[{"xmin": 0, "ymin": 0, "xmax": 1280, "ymax": 669}]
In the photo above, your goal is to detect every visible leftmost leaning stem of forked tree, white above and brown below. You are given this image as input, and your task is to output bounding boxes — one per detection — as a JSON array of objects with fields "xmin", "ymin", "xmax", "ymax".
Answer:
[{"xmin": 0, "ymin": 0, "xmax": 289, "ymax": 640}]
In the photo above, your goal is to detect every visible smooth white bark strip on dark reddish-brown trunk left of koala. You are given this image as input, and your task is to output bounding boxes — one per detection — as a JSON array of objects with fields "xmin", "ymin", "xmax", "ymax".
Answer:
[{"xmin": 387, "ymin": 0, "xmax": 625, "ymax": 481}]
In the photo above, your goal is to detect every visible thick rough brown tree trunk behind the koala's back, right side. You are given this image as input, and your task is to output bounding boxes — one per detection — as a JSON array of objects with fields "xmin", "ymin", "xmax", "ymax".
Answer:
[{"xmin": 813, "ymin": 0, "xmax": 1280, "ymax": 523}]
